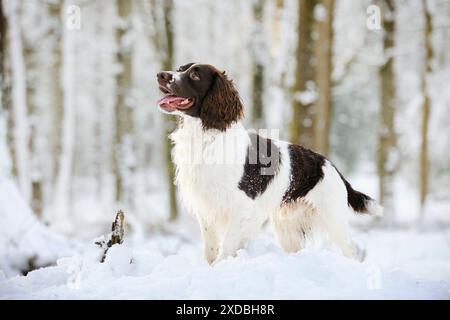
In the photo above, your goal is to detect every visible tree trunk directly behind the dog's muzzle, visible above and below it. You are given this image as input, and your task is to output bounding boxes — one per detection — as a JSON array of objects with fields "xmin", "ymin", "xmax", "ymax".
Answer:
[{"xmin": 150, "ymin": 0, "xmax": 178, "ymax": 220}]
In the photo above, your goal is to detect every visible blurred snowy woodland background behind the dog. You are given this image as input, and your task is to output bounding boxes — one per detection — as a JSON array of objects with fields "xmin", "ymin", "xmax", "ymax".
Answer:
[{"xmin": 0, "ymin": 0, "xmax": 450, "ymax": 236}]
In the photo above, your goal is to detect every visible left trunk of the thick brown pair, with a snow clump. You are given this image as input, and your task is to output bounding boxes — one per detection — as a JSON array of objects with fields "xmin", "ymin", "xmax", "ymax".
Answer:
[{"xmin": 291, "ymin": 0, "xmax": 316, "ymax": 147}]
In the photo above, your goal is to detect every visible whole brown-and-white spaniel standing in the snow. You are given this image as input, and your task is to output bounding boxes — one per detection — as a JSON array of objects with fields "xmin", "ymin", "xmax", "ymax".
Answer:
[{"xmin": 157, "ymin": 63, "xmax": 382, "ymax": 264}]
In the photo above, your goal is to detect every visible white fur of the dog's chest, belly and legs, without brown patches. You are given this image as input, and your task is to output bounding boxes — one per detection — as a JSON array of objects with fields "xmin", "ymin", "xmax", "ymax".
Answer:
[{"xmin": 170, "ymin": 116, "xmax": 362, "ymax": 264}]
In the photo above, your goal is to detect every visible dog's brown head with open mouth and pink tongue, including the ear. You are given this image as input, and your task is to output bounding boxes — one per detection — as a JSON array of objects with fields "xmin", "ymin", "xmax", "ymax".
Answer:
[{"xmin": 157, "ymin": 63, "xmax": 243, "ymax": 131}]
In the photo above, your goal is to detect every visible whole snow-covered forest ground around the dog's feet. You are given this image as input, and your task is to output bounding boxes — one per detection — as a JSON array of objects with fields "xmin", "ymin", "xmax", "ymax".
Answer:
[{"xmin": 0, "ymin": 177, "xmax": 450, "ymax": 299}]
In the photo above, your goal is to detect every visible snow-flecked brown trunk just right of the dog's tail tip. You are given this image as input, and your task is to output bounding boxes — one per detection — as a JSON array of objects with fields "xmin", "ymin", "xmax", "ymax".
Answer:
[{"xmin": 377, "ymin": 0, "xmax": 396, "ymax": 215}]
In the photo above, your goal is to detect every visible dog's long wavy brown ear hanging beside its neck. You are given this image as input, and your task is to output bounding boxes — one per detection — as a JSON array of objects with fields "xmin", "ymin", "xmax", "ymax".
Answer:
[{"xmin": 200, "ymin": 71, "xmax": 243, "ymax": 131}]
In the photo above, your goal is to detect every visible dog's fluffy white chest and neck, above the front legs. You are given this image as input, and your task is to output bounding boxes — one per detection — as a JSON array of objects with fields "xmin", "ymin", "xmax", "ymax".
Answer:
[{"xmin": 171, "ymin": 119, "xmax": 249, "ymax": 214}]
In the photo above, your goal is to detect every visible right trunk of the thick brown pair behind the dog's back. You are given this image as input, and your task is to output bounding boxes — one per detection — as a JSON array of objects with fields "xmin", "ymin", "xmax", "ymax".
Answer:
[{"xmin": 313, "ymin": 0, "xmax": 334, "ymax": 155}]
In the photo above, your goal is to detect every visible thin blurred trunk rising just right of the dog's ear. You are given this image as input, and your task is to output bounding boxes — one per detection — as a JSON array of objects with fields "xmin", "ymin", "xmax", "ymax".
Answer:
[{"xmin": 252, "ymin": 0, "xmax": 266, "ymax": 126}]
